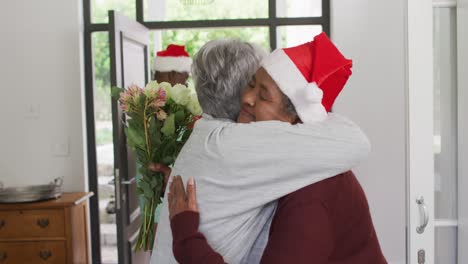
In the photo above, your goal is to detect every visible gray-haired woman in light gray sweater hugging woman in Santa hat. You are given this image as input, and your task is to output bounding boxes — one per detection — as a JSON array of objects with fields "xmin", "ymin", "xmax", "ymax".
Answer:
[{"xmin": 151, "ymin": 37, "xmax": 370, "ymax": 264}]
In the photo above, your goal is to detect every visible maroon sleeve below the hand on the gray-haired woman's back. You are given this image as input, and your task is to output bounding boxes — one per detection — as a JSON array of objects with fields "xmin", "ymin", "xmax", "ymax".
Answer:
[{"xmin": 171, "ymin": 211, "xmax": 225, "ymax": 264}]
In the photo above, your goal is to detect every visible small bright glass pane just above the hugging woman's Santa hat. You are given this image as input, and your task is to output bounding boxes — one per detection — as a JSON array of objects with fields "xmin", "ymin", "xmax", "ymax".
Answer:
[{"xmin": 276, "ymin": 25, "xmax": 322, "ymax": 48}]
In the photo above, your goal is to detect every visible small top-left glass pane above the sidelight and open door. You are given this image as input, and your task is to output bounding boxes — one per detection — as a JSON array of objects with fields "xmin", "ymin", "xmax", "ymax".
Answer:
[{"xmin": 91, "ymin": 0, "xmax": 136, "ymax": 23}]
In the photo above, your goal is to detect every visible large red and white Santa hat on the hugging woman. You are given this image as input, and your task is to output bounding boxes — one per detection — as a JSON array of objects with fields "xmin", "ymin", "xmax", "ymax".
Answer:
[{"xmin": 262, "ymin": 33, "xmax": 352, "ymax": 123}]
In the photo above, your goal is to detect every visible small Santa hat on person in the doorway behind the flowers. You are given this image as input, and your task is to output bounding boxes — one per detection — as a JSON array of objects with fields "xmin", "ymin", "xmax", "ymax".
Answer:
[{"xmin": 154, "ymin": 44, "xmax": 192, "ymax": 72}]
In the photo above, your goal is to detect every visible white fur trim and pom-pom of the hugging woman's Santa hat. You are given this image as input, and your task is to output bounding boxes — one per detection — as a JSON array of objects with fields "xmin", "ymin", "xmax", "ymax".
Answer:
[{"xmin": 262, "ymin": 49, "xmax": 327, "ymax": 123}]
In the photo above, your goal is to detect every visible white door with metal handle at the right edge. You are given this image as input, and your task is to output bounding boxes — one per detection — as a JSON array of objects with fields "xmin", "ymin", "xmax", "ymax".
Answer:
[{"xmin": 407, "ymin": 0, "xmax": 468, "ymax": 264}]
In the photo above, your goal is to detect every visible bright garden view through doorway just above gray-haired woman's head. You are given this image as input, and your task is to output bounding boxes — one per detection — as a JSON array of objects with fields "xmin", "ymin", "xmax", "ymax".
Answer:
[{"xmin": 150, "ymin": 27, "xmax": 270, "ymax": 76}]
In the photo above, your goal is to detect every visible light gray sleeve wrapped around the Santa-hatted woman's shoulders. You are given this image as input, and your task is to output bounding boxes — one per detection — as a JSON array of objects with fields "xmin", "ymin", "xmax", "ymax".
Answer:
[{"xmin": 197, "ymin": 114, "xmax": 370, "ymax": 208}]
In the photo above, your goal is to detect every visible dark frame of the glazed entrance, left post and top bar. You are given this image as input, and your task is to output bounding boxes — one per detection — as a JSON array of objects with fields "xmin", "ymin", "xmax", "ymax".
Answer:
[{"xmin": 81, "ymin": 0, "xmax": 331, "ymax": 263}]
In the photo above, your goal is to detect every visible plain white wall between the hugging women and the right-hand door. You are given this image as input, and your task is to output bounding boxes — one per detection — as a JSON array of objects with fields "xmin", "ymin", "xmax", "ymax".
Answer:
[{"xmin": 331, "ymin": 0, "xmax": 407, "ymax": 263}]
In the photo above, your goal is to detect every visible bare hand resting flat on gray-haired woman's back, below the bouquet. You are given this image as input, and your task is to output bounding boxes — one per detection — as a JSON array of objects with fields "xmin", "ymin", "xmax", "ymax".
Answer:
[{"xmin": 167, "ymin": 176, "xmax": 198, "ymax": 219}]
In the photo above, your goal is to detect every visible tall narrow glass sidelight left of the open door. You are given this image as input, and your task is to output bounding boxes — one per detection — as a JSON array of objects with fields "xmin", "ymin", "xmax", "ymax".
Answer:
[{"xmin": 92, "ymin": 32, "xmax": 118, "ymax": 264}]
